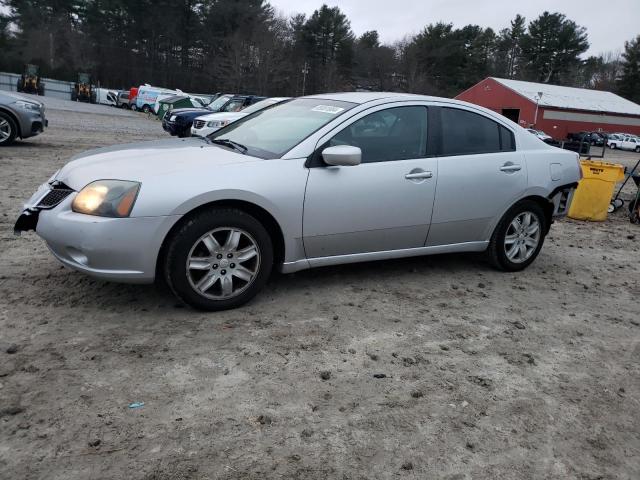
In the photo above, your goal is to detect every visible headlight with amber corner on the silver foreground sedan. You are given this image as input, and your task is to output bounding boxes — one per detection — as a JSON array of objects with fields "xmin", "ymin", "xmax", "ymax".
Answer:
[{"xmin": 71, "ymin": 180, "xmax": 140, "ymax": 218}]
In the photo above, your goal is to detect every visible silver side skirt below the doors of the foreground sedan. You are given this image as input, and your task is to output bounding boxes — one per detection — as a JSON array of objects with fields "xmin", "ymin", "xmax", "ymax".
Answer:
[{"xmin": 281, "ymin": 241, "xmax": 489, "ymax": 273}]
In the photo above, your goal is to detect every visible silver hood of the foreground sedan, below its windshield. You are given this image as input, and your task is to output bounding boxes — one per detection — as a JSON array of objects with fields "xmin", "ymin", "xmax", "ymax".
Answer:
[{"xmin": 55, "ymin": 138, "xmax": 263, "ymax": 190}]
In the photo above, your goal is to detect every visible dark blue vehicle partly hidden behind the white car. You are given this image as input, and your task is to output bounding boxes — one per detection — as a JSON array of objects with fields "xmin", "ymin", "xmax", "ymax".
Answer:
[{"xmin": 162, "ymin": 94, "xmax": 267, "ymax": 138}]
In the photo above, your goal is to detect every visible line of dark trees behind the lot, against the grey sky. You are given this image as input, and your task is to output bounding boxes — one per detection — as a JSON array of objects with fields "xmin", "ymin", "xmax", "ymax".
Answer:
[{"xmin": 0, "ymin": 0, "xmax": 640, "ymax": 102}]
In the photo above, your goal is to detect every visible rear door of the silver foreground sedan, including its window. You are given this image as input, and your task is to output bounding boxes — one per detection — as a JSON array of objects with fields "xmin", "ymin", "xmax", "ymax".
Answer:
[{"xmin": 427, "ymin": 107, "xmax": 527, "ymax": 246}]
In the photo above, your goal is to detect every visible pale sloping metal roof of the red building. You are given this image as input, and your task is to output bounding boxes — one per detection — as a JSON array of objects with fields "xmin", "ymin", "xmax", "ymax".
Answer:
[{"xmin": 491, "ymin": 77, "xmax": 640, "ymax": 115}]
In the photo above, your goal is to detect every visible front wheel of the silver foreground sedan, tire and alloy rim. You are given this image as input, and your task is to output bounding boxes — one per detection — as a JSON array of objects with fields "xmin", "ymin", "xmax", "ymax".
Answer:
[{"xmin": 163, "ymin": 208, "xmax": 273, "ymax": 311}]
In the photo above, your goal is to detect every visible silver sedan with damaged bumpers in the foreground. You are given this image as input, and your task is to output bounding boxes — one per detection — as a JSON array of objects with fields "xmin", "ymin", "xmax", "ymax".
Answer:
[{"xmin": 15, "ymin": 92, "xmax": 581, "ymax": 310}]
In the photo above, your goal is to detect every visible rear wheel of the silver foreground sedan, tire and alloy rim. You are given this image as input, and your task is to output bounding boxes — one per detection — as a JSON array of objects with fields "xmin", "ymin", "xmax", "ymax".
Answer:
[{"xmin": 487, "ymin": 200, "xmax": 547, "ymax": 272}]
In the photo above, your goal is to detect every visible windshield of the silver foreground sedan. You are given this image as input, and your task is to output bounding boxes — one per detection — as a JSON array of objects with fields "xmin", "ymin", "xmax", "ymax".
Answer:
[{"xmin": 208, "ymin": 98, "xmax": 356, "ymax": 159}]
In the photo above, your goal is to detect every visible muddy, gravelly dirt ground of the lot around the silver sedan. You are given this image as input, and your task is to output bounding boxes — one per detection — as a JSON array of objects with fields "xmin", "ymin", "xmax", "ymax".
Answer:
[{"xmin": 0, "ymin": 95, "xmax": 640, "ymax": 480}]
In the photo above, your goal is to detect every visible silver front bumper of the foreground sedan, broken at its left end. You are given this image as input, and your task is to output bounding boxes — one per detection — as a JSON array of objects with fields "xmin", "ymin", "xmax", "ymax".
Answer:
[{"xmin": 15, "ymin": 188, "xmax": 181, "ymax": 283}]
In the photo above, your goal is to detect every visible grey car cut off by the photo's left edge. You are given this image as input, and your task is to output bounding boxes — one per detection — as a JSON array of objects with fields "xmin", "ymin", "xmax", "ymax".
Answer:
[{"xmin": 0, "ymin": 91, "xmax": 48, "ymax": 147}]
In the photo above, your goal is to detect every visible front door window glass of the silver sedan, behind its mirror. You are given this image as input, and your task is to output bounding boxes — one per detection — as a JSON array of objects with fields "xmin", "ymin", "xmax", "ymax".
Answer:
[{"xmin": 327, "ymin": 106, "xmax": 427, "ymax": 163}]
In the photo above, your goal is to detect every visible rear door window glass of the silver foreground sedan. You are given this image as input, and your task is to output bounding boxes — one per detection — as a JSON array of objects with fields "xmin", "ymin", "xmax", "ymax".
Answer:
[{"xmin": 441, "ymin": 108, "xmax": 516, "ymax": 155}]
